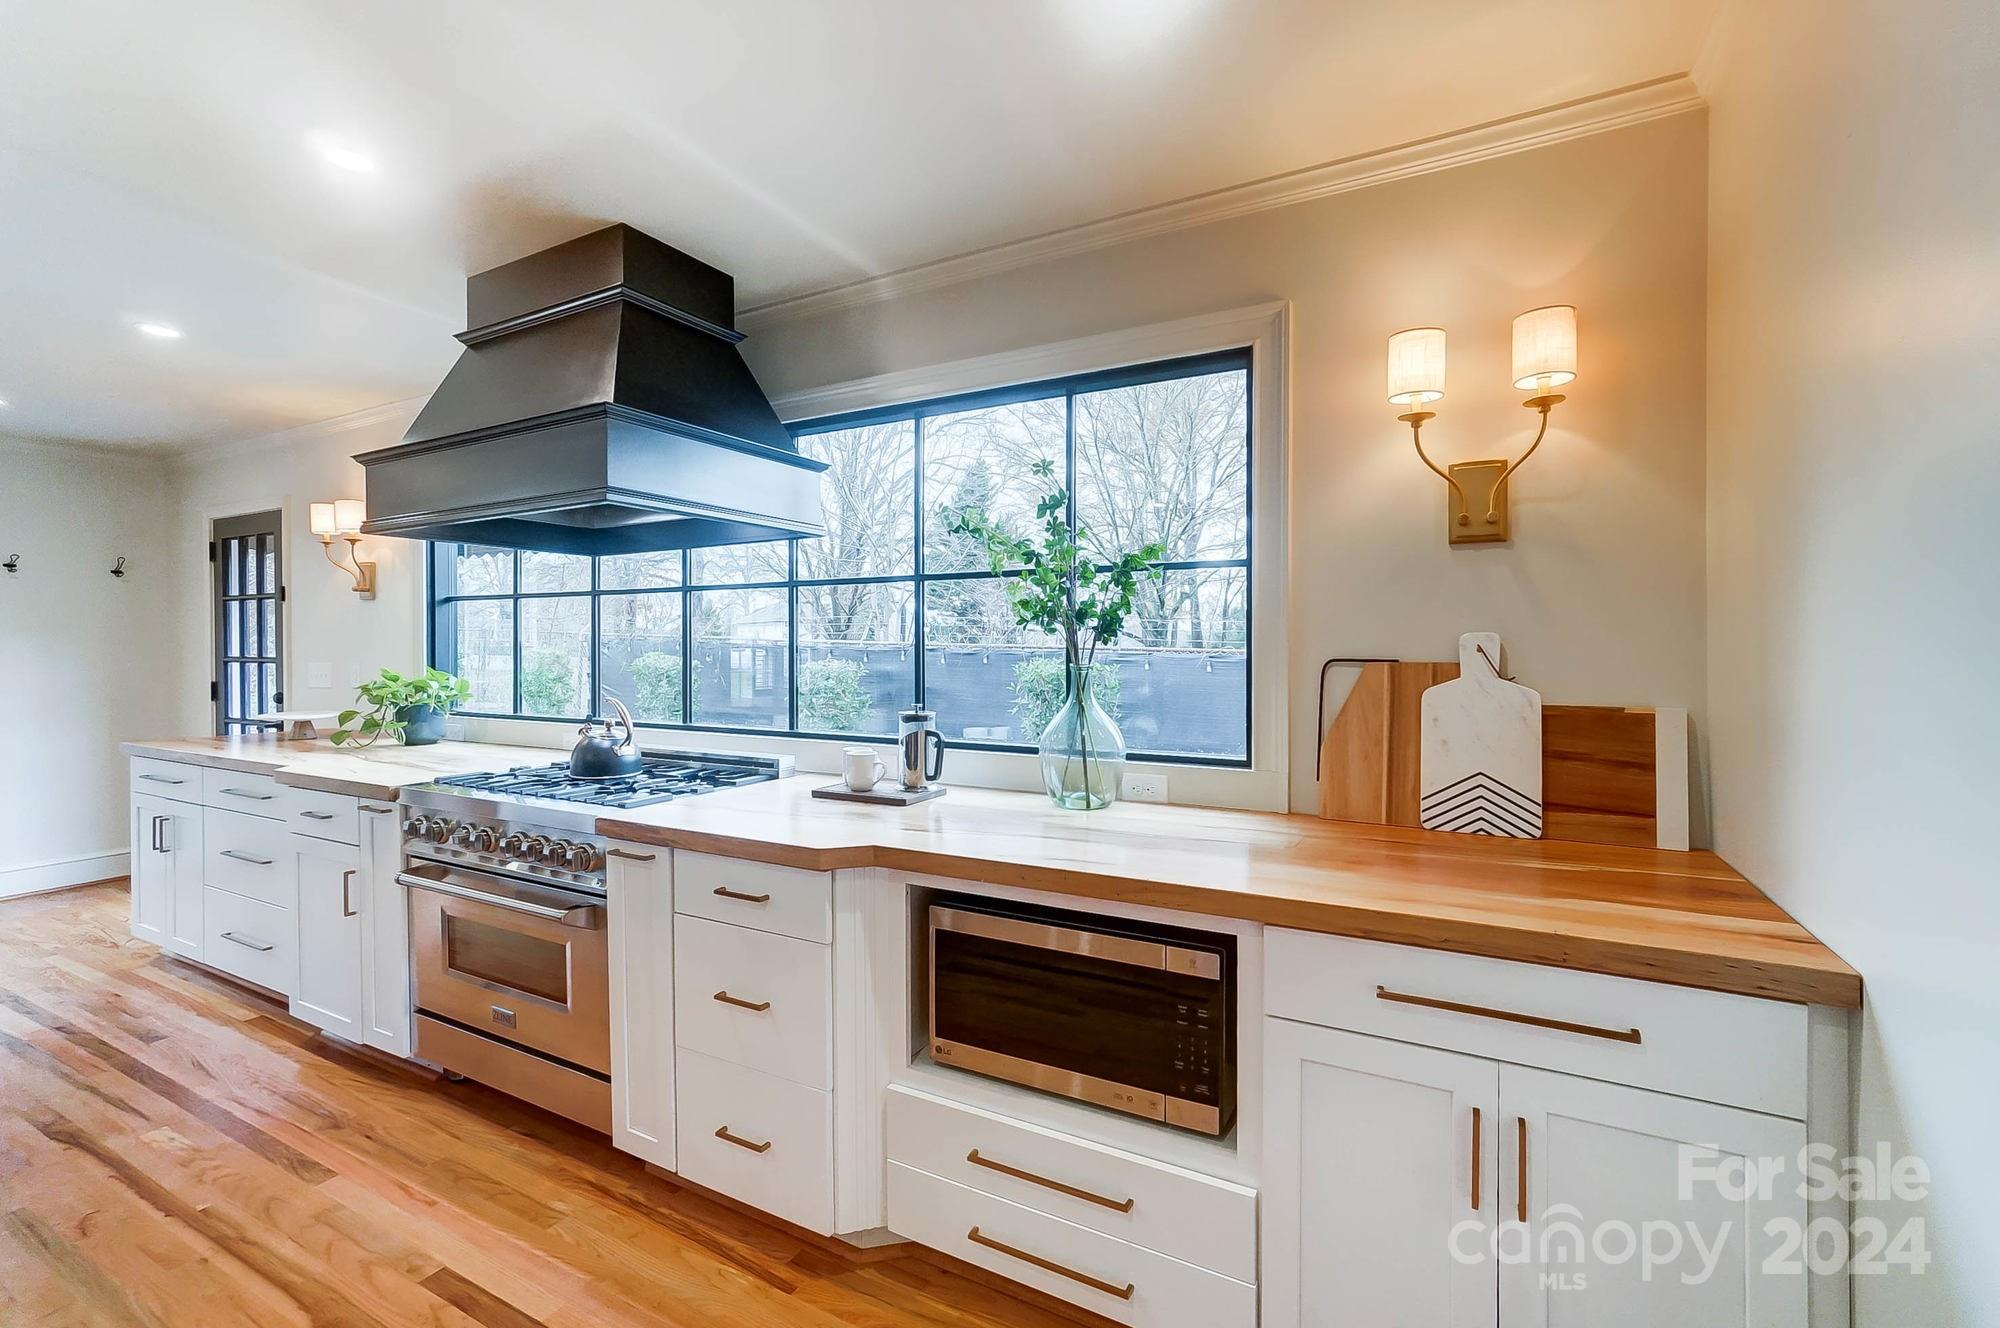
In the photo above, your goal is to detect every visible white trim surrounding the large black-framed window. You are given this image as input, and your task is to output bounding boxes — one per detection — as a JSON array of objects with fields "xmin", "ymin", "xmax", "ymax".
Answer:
[{"xmin": 460, "ymin": 300, "xmax": 1292, "ymax": 812}]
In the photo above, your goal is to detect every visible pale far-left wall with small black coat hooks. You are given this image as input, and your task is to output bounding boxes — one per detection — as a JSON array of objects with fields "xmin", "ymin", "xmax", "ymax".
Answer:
[{"xmin": 0, "ymin": 438, "xmax": 186, "ymax": 896}]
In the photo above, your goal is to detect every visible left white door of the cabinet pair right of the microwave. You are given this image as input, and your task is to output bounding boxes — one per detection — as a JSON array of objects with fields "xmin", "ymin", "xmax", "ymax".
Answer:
[{"xmin": 1262, "ymin": 1018, "xmax": 1500, "ymax": 1328}]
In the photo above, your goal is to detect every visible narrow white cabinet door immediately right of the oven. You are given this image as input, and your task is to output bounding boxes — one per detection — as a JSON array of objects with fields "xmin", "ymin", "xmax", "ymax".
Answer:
[{"xmin": 606, "ymin": 844, "xmax": 678, "ymax": 1172}]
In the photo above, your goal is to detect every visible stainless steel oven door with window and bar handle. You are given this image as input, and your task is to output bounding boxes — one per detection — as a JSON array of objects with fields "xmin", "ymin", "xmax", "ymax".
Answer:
[{"xmin": 396, "ymin": 862, "xmax": 612, "ymax": 1074}]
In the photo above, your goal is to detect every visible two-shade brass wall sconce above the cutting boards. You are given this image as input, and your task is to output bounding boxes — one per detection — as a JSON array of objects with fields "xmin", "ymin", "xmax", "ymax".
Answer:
[{"xmin": 1388, "ymin": 304, "xmax": 1576, "ymax": 544}]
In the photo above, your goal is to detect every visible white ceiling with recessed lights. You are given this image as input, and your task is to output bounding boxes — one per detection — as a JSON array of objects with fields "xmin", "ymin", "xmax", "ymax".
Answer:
[{"xmin": 0, "ymin": 0, "xmax": 1716, "ymax": 444}]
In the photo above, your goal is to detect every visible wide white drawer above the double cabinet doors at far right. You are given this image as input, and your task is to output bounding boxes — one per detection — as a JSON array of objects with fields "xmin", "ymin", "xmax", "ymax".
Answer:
[{"xmin": 1264, "ymin": 928, "xmax": 1806, "ymax": 1120}]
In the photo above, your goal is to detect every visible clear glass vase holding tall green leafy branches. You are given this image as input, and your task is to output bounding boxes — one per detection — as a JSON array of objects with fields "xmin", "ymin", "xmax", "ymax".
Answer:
[{"xmin": 946, "ymin": 460, "xmax": 1166, "ymax": 812}]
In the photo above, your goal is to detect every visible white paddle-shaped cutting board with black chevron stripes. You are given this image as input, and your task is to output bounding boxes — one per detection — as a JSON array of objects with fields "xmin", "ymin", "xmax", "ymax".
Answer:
[{"xmin": 1418, "ymin": 632, "xmax": 1542, "ymax": 840}]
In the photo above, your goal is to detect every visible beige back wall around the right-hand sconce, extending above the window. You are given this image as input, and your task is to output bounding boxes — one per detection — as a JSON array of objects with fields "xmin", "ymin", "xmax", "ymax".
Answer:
[{"xmin": 744, "ymin": 114, "xmax": 1706, "ymax": 808}]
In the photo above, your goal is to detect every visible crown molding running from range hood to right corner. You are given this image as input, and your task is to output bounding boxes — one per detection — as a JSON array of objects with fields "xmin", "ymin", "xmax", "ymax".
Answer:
[{"xmin": 736, "ymin": 74, "xmax": 1702, "ymax": 328}]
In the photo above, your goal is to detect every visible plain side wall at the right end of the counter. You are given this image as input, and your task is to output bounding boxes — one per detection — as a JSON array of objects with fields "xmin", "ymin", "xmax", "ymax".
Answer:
[{"xmin": 1704, "ymin": 0, "xmax": 2000, "ymax": 1328}]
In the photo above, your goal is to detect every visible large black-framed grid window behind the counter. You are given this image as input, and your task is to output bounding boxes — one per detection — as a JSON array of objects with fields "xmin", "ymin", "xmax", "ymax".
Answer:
[{"xmin": 430, "ymin": 350, "xmax": 1254, "ymax": 766}]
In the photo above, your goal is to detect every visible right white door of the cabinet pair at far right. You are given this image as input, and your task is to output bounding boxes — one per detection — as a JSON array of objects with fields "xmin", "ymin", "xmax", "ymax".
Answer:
[{"xmin": 1500, "ymin": 1066, "xmax": 1810, "ymax": 1328}]
